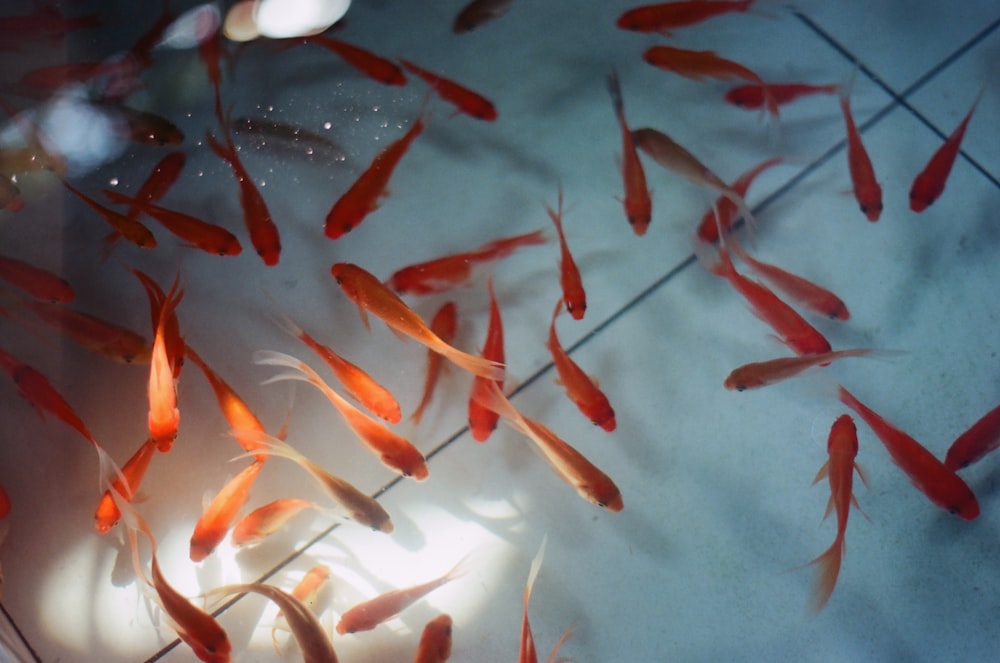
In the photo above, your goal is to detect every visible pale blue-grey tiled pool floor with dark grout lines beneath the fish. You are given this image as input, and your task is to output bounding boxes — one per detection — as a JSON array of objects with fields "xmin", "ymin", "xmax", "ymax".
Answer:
[{"xmin": 0, "ymin": 0, "xmax": 1000, "ymax": 663}]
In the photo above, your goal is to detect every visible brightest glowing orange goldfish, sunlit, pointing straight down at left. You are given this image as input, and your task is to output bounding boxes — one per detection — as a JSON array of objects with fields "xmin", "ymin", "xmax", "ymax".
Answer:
[{"xmin": 148, "ymin": 280, "xmax": 184, "ymax": 453}]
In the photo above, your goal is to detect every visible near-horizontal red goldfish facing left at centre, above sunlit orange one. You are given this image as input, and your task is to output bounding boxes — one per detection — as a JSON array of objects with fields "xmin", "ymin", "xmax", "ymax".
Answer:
[{"xmin": 386, "ymin": 229, "xmax": 548, "ymax": 295}]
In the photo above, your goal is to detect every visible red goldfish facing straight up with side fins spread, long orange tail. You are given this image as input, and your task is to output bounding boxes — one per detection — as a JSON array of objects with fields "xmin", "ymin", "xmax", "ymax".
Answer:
[{"xmin": 809, "ymin": 414, "xmax": 868, "ymax": 613}]
